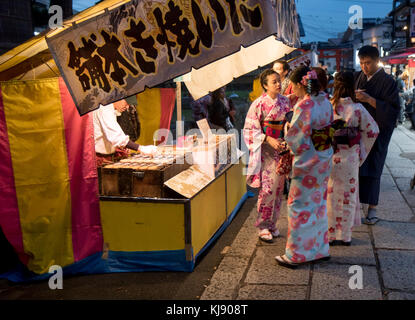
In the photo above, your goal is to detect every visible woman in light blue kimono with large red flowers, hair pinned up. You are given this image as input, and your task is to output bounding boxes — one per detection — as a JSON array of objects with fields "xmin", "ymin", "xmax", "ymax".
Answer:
[{"xmin": 275, "ymin": 67, "xmax": 333, "ymax": 268}]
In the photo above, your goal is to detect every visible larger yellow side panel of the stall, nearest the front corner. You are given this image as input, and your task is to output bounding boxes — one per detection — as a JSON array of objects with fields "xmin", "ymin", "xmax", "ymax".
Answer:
[{"xmin": 191, "ymin": 174, "xmax": 226, "ymax": 256}]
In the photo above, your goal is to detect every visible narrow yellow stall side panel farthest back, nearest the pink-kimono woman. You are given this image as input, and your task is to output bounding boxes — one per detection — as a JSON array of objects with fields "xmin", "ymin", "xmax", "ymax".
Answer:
[{"xmin": 226, "ymin": 161, "xmax": 246, "ymax": 216}]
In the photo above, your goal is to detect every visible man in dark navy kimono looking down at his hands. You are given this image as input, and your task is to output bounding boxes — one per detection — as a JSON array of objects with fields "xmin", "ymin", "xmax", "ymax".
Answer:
[{"xmin": 355, "ymin": 46, "xmax": 400, "ymax": 225}]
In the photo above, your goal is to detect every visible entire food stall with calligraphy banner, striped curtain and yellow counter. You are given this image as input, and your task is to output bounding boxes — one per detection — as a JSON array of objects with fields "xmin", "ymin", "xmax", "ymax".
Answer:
[{"xmin": 0, "ymin": 0, "xmax": 298, "ymax": 281}]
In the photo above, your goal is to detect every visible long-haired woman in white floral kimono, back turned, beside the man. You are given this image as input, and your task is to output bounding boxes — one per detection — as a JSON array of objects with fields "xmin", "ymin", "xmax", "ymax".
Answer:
[{"xmin": 327, "ymin": 72, "xmax": 379, "ymax": 245}]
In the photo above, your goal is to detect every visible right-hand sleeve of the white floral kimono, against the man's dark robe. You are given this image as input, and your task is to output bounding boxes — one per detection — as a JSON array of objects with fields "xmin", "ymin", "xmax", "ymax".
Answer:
[{"xmin": 355, "ymin": 103, "xmax": 379, "ymax": 166}]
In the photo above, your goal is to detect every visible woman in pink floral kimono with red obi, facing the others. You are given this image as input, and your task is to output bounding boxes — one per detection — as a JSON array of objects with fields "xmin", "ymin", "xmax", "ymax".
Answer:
[{"xmin": 243, "ymin": 70, "xmax": 290, "ymax": 242}]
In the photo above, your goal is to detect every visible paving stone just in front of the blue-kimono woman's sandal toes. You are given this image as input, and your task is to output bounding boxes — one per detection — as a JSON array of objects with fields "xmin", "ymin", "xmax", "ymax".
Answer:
[{"xmin": 245, "ymin": 245, "xmax": 310, "ymax": 285}]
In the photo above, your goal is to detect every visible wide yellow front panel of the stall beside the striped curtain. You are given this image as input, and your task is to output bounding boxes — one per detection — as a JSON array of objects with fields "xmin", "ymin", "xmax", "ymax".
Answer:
[{"xmin": 100, "ymin": 201, "xmax": 184, "ymax": 252}]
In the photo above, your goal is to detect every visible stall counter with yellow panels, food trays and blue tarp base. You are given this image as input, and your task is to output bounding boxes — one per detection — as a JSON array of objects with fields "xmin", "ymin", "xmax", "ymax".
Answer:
[{"xmin": 100, "ymin": 132, "xmax": 248, "ymax": 271}]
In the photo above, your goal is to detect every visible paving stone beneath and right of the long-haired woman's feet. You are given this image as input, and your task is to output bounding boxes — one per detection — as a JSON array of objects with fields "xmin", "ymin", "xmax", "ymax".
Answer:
[{"xmin": 330, "ymin": 232, "xmax": 376, "ymax": 266}]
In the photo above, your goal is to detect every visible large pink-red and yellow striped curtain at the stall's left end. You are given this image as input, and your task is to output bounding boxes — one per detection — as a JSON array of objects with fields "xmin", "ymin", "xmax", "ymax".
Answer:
[{"xmin": 0, "ymin": 78, "xmax": 103, "ymax": 274}]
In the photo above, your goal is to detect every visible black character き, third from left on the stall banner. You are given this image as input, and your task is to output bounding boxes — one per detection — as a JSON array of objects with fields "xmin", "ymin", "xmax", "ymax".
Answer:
[{"xmin": 124, "ymin": 19, "xmax": 158, "ymax": 73}]
